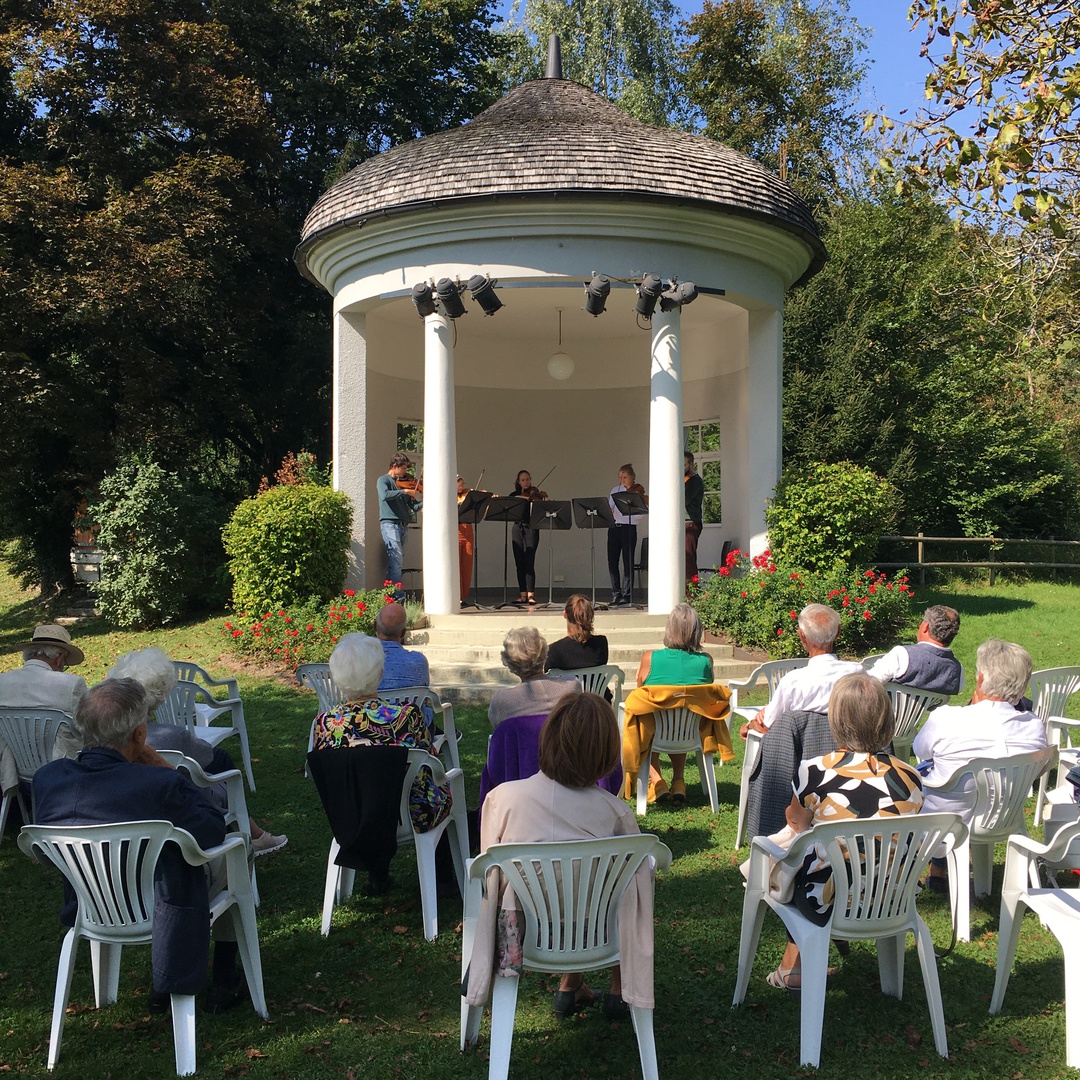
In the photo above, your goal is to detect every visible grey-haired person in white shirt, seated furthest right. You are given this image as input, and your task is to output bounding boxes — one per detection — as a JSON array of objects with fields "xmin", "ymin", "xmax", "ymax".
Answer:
[{"xmin": 913, "ymin": 637, "xmax": 1047, "ymax": 892}]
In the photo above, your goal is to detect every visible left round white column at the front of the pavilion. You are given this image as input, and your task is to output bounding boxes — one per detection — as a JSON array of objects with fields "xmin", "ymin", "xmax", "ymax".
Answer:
[{"xmin": 423, "ymin": 315, "xmax": 460, "ymax": 615}]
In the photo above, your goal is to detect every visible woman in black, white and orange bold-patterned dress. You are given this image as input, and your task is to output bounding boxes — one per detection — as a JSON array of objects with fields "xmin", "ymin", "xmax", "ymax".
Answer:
[{"xmin": 768, "ymin": 672, "xmax": 922, "ymax": 989}]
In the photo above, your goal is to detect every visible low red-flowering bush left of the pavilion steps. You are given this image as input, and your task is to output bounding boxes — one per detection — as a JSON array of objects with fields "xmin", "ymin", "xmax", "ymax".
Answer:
[{"xmin": 221, "ymin": 588, "xmax": 393, "ymax": 665}]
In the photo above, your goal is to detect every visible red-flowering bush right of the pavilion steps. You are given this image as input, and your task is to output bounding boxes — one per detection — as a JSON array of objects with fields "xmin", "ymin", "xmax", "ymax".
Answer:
[{"xmin": 688, "ymin": 550, "xmax": 914, "ymax": 660}]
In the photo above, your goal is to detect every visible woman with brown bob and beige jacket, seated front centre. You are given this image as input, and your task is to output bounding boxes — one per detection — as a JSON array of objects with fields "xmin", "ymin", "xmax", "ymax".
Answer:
[{"xmin": 462, "ymin": 693, "xmax": 652, "ymax": 1020}]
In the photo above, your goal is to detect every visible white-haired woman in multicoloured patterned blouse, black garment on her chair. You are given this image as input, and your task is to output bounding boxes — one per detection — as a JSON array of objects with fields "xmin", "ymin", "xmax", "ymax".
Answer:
[{"xmin": 312, "ymin": 634, "xmax": 450, "ymax": 896}]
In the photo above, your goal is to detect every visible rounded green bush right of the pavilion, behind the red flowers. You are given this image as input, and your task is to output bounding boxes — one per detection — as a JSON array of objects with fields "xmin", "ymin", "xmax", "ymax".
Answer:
[{"xmin": 765, "ymin": 461, "xmax": 901, "ymax": 571}]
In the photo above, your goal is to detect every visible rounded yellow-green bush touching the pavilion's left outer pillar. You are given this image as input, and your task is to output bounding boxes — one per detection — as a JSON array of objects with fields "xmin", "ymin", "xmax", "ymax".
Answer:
[{"xmin": 222, "ymin": 484, "xmax": 352, "ymax": 611}]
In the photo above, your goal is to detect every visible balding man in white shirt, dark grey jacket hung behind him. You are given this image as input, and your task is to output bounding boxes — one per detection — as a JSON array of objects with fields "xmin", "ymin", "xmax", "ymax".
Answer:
[{"xmin": 741, "ymin": 604, "xmax": 859, "ymax": 838}]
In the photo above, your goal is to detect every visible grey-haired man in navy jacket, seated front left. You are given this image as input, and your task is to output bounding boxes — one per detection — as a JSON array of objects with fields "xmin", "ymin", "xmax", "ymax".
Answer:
[{"xmin": 33, "ymin": 678, "xmax": 246, "ymax": 1012}]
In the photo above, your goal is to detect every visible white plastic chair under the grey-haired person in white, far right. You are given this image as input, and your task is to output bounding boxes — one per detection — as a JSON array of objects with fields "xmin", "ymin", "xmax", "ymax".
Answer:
[{"xmin": 922, "ymin": 746, "xmax": 1057, "ymax": 942}]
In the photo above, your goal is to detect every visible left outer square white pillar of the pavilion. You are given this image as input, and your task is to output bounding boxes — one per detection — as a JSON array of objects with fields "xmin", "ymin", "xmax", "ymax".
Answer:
[{"xmin": 333, "ymin": 311, "xmax": 367, "ymax": 589}]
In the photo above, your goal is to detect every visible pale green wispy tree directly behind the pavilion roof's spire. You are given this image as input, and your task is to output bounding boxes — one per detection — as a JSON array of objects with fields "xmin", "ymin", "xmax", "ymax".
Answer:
[{"xmin": 498, "ymin": 0, "xmax": 686, "ymax": 125}]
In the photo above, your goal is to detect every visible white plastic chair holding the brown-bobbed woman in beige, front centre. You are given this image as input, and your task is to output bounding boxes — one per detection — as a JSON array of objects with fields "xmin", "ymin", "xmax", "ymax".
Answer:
[{"xmin": 461, "ymin": 833, "xmax": 672, "ymax": 1080}]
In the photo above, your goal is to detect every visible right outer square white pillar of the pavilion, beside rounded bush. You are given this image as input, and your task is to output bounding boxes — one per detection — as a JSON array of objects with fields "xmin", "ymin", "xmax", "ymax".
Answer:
[{"xmin": 746, "ymin": 310, "xmax": 784, "ymax": 555}]
